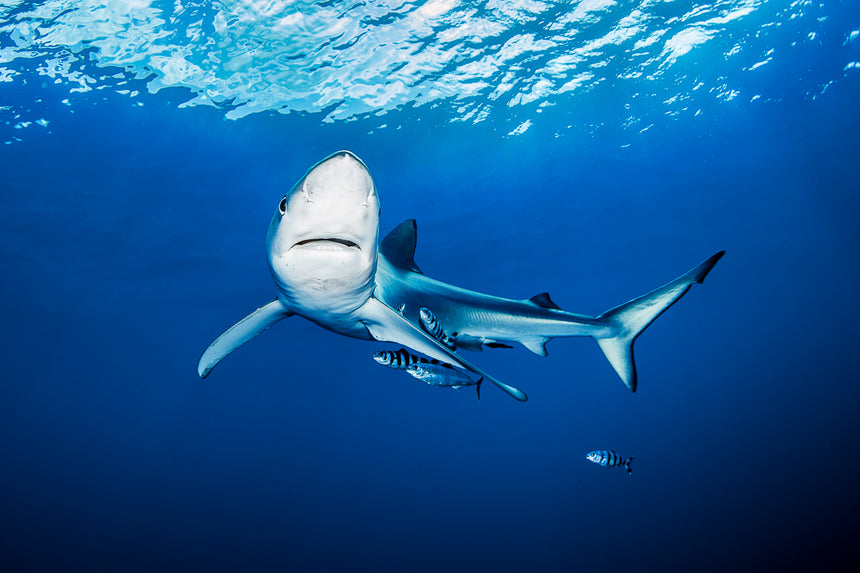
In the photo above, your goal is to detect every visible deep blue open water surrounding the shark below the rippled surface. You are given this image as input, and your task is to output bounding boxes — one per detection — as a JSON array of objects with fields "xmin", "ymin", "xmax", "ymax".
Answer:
[{"xmin": 0, "ymin": 25, "xmax": 860, "ymax": 572}]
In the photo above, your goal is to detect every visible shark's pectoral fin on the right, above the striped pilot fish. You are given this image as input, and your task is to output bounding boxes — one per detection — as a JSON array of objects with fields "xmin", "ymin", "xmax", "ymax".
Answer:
[{"xmin": 360, "ymin": 297, "xmax": 528, "ymax": 402}]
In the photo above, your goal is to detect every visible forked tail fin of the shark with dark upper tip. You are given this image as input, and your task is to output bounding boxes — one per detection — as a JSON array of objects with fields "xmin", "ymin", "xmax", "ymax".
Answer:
[{"xmin": 594, "ymin": 251, "xmax": 725, "ymax": 392}]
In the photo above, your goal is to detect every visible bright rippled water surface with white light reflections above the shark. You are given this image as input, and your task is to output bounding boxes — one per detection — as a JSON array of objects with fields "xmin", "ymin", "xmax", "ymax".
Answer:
[{"xmin": 0, "ymin": 0, "xmax": 857, "ymax": 132}]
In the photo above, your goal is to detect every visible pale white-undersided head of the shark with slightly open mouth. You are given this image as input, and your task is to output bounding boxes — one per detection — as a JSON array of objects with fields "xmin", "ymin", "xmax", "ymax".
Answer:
[{"xmin": 266, "ymin": 151, "xmax": 380, "ymax": 318}]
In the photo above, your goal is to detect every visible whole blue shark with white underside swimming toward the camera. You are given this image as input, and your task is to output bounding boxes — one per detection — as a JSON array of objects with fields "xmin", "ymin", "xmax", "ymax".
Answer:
[{"xmin": 197, "ymin": 150, "xmax": 725, "ymax": 402}]
